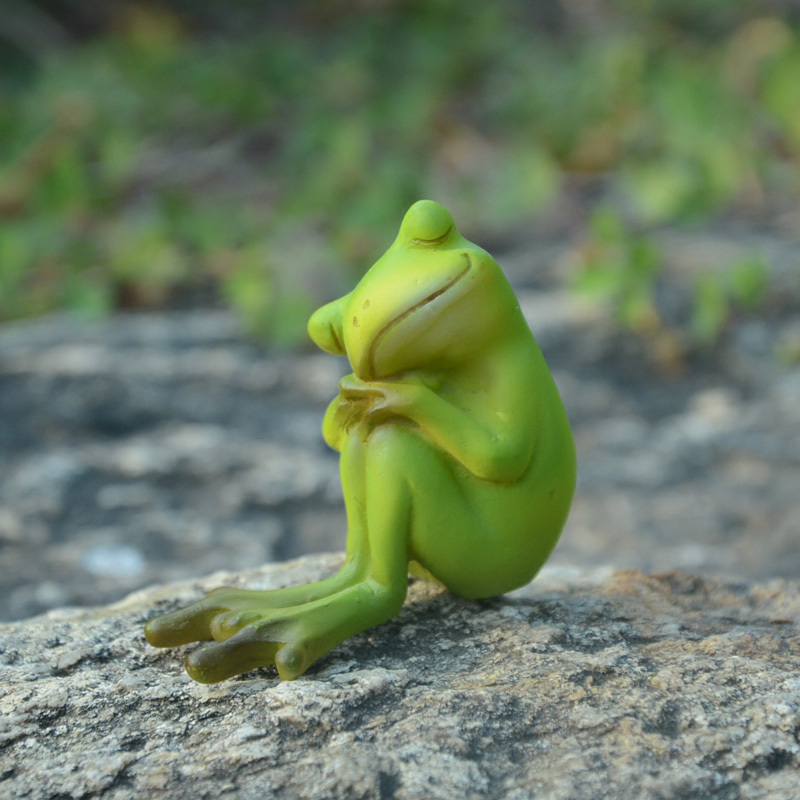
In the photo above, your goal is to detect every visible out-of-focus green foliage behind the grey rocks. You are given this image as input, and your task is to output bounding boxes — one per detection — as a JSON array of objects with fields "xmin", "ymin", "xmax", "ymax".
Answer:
[{"xmin": 0, "ymin": 0, "xmax": 800, "ymax": 343}]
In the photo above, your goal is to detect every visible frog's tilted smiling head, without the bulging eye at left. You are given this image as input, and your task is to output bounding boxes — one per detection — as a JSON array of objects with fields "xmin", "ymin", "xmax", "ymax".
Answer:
[{"xmin": 343, "ymin": 200, "xmax": 516, "ymax": 380}]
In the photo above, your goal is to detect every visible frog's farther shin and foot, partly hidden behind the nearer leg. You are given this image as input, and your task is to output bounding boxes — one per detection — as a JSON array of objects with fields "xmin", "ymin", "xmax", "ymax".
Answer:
[{"xmin": 145, "ymin": 434, "xmax": 369, "ymax": 647}]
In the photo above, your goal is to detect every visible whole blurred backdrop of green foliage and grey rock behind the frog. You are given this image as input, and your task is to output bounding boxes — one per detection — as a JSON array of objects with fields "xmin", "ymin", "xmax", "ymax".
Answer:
[{"xmin": 0, "ymin": 0, "xmax": 800, "ymax": 618}]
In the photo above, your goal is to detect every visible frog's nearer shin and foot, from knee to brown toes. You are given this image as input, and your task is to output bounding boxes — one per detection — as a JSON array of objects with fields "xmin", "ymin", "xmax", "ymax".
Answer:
[{"xmin": 143, "ymin": 427, "xmax": 411, "ymax": 683}]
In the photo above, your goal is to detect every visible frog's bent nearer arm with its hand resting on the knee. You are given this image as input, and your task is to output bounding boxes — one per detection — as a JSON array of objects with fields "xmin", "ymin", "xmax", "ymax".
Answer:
[{"xmin": 344, "ymin": 344, "xmax": 538, "ymax": 483}]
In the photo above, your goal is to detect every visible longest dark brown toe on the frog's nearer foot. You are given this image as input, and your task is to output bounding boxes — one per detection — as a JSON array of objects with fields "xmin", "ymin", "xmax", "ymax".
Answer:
[{"xmin": 184, "ymin": 625, "xmax": 283, "ymax": 683}]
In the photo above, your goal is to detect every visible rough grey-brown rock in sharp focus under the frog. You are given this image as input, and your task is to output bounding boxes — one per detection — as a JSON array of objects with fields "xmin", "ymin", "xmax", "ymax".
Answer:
[{"xmin": 0, "ymin": 556, "xmax": 800, "ymax": 800}]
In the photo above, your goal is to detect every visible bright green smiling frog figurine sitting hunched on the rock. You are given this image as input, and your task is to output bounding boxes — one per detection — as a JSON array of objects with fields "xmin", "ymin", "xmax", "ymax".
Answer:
[{"xmin": 145, "ymin": 200, "xmax": 575, "ymax": 683}]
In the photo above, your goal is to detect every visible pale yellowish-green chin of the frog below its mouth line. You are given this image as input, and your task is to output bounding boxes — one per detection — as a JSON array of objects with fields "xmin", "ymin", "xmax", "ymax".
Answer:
[{"xmin": 353, "ymin": 256, "xmax": 473, "ymax": 380}]
